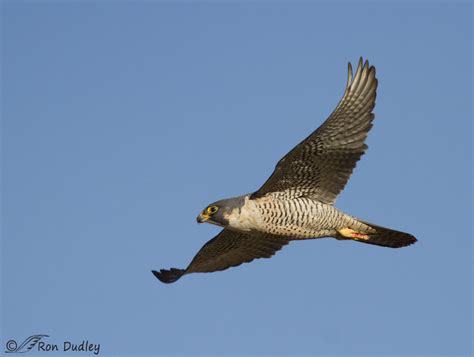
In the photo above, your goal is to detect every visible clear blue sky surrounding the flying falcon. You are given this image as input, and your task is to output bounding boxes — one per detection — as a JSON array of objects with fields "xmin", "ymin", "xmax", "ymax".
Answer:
[{"xmin": 0, "ymin": 1, "xmax": 473, "ymax": 356}]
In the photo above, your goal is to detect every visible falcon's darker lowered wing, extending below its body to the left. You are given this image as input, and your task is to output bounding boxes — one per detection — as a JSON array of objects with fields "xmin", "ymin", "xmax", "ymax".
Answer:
[{"xmin": 152, "ymin": 229, "xmax": 289, "ymax": 283}]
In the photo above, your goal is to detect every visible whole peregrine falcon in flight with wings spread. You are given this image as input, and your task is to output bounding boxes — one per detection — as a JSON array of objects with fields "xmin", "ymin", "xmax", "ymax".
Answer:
[{"xmin": 152, "ymin": 58, "xmax": 416, "ymax": 283}]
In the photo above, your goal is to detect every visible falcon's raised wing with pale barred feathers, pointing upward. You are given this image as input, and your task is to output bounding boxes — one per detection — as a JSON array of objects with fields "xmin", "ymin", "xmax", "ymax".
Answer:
[{"xmin": 251, "ymin": 58, "xmax": 377, "ymax": 204}]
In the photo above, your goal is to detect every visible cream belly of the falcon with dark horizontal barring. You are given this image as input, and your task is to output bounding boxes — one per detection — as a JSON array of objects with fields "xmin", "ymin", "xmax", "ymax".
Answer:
[{"xmin": 256, "ymin": 197, "xmax": 352, "ymax": 239}]
